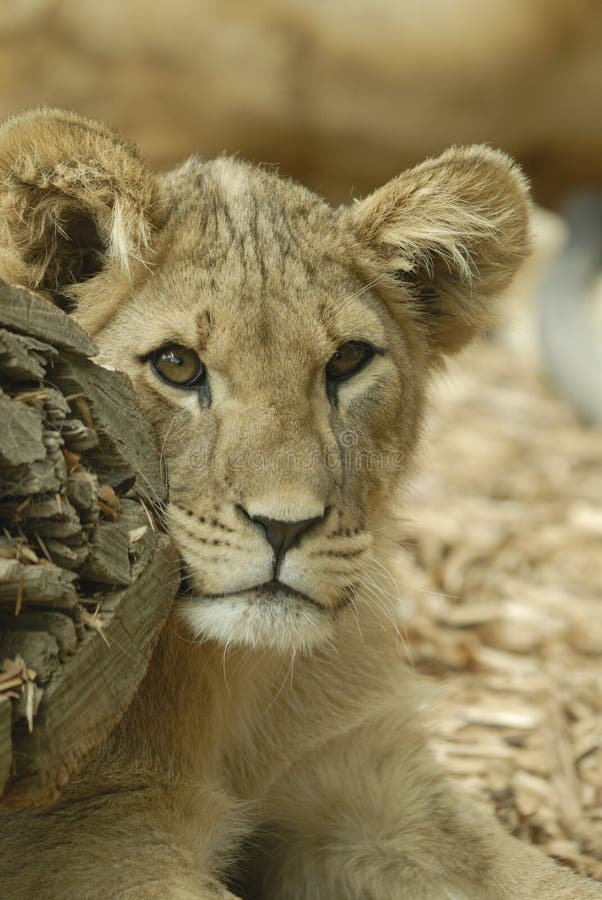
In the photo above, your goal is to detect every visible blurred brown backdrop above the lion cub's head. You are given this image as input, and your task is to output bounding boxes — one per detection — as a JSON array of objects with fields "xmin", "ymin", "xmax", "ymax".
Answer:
[{"xmin": 0, "ymin": 0, "xmax": 602, "ymax": 207}]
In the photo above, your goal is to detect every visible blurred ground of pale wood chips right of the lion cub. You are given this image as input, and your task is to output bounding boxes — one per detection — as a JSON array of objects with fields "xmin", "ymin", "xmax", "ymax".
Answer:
[{"xmin": 390, "ymin": 343, "xmax": 602, "ymax": 880}]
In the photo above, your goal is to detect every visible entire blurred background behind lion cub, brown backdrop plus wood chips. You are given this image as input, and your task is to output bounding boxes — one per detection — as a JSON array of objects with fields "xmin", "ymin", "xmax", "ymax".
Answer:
[{"xmin": 0, "ymin": 0, "xmax": 602, "ymax": 880}]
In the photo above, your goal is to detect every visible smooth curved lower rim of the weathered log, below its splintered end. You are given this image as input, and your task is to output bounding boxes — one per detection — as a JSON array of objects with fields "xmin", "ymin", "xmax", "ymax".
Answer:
[{"xmin": 0, "ymin": 535, "xmax": 176, "ymax": 807}]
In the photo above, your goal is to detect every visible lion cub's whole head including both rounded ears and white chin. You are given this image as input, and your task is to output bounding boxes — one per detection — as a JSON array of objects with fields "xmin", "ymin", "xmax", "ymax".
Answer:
[{"xmin": 0, "ymin": 110, "xmax": 527, "ymax": 649}]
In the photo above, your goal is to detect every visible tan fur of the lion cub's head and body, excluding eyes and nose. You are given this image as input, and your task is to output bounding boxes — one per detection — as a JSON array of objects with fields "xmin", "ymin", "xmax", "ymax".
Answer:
[{"xmin": 0, "ymin": 112, "xmax": 602, "ymax": 900}]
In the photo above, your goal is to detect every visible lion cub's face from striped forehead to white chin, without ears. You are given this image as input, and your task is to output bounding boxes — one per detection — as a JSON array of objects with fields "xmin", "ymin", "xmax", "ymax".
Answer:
[{"xmin": 96, "ymin": 160, "xmax": 423, "ymax": 647}]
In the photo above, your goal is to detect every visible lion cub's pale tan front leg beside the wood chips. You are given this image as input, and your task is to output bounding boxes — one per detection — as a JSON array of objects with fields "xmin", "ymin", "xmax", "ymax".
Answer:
[{"xmin": 255, "ymin": 713, "xmax": 602, "ymax": 900}]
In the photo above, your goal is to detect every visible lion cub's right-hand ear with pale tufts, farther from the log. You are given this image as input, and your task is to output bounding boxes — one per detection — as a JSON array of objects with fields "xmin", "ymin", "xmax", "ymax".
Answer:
[{"xmin": 347, "ymin": 145, "xmax": 529, "ymax": 353}]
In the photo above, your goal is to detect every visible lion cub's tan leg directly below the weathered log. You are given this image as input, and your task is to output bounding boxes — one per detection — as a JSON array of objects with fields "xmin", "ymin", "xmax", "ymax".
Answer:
[{"xmin": 0, "ymin": 776, "xmax": 245, "ymax": 900}]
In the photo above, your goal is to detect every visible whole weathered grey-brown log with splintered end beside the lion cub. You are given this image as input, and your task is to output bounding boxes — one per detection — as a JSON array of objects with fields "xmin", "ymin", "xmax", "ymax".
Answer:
[{"xmin": 0, "ymin": 282, "xmax": 178, "ymax": 806}]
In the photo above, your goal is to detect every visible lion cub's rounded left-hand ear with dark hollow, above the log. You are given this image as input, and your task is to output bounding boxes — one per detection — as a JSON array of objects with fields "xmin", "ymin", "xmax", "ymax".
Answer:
[{"xmin": 0, "ymin": 109, "xmax": 164, "ymax": 330}]
